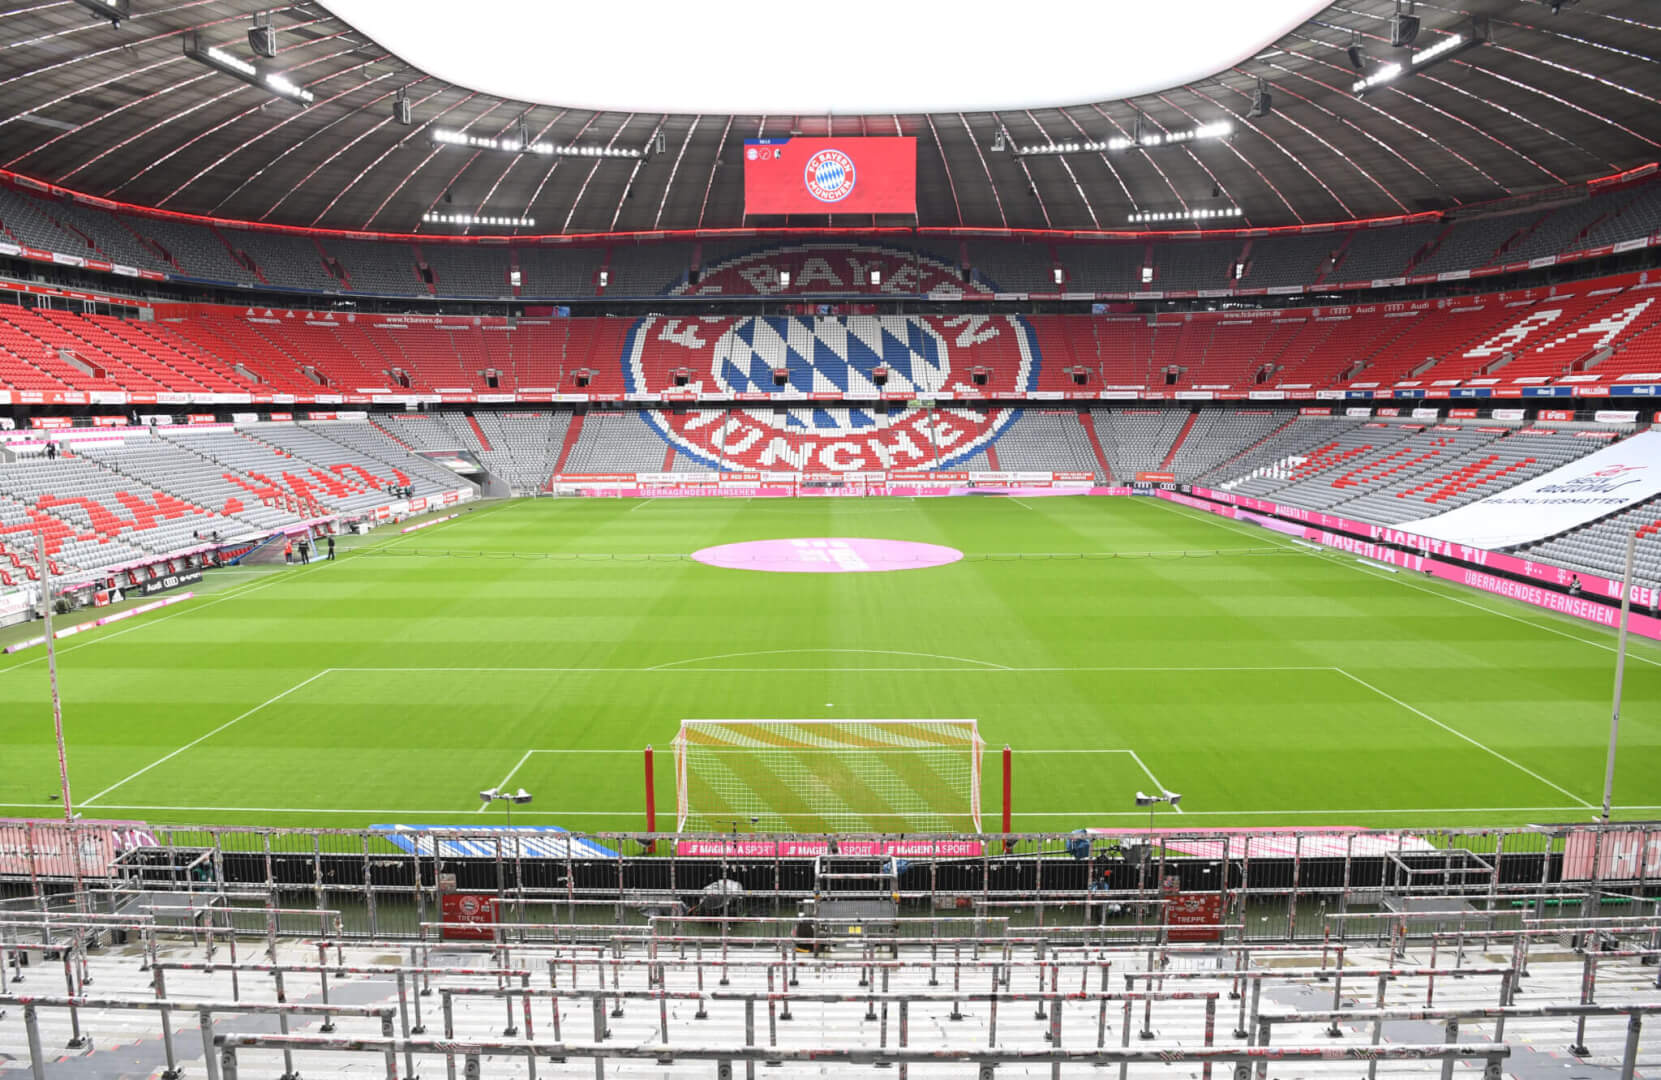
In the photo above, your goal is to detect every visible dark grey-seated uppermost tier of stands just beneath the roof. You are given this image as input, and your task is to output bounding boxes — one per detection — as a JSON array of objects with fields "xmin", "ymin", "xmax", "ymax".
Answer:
[{"xmin": 0, "ymin": 178, "xmax": 1661, "ymax": 299}]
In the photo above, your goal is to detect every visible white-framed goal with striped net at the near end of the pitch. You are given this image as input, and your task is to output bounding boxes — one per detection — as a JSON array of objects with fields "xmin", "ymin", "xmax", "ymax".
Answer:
[{"xmin": 674, "ymin": 719, "xmax": 985, "ymax": 832}]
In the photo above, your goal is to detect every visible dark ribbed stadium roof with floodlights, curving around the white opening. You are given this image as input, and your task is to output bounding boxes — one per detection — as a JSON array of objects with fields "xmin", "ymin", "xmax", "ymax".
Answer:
[{"xmin": 0, "ymin": 0, "xmax": 1661, "ymax": 234}]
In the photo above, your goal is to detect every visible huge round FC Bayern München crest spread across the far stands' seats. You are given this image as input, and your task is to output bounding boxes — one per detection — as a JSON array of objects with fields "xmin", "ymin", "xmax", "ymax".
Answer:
[{"xmin": 623, "ymin": 248, "xmax": 1040, "ymax": 472}]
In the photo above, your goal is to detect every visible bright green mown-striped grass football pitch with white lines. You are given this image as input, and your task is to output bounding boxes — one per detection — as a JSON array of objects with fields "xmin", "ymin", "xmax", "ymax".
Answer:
[{"xmin": 0, "ymin": 497, "xmax": 1661, "ymax": 831}]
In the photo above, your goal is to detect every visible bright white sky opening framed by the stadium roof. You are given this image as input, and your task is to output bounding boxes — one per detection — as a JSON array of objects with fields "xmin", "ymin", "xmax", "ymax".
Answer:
[{"xmin": 327, "ymin": 0, "xmax": 1327, "ymax": 115}]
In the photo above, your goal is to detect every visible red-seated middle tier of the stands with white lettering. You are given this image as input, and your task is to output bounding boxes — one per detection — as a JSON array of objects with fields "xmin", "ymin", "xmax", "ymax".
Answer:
[{"xmin": 0, "ymin": 276, "xmax": 1661, "ymax": 404}]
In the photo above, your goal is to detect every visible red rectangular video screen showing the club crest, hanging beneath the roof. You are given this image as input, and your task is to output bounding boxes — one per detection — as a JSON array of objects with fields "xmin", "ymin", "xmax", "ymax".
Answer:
[{"xmin": 744, "ymin": 135, "xmax": 917, "ymax": 214}]
